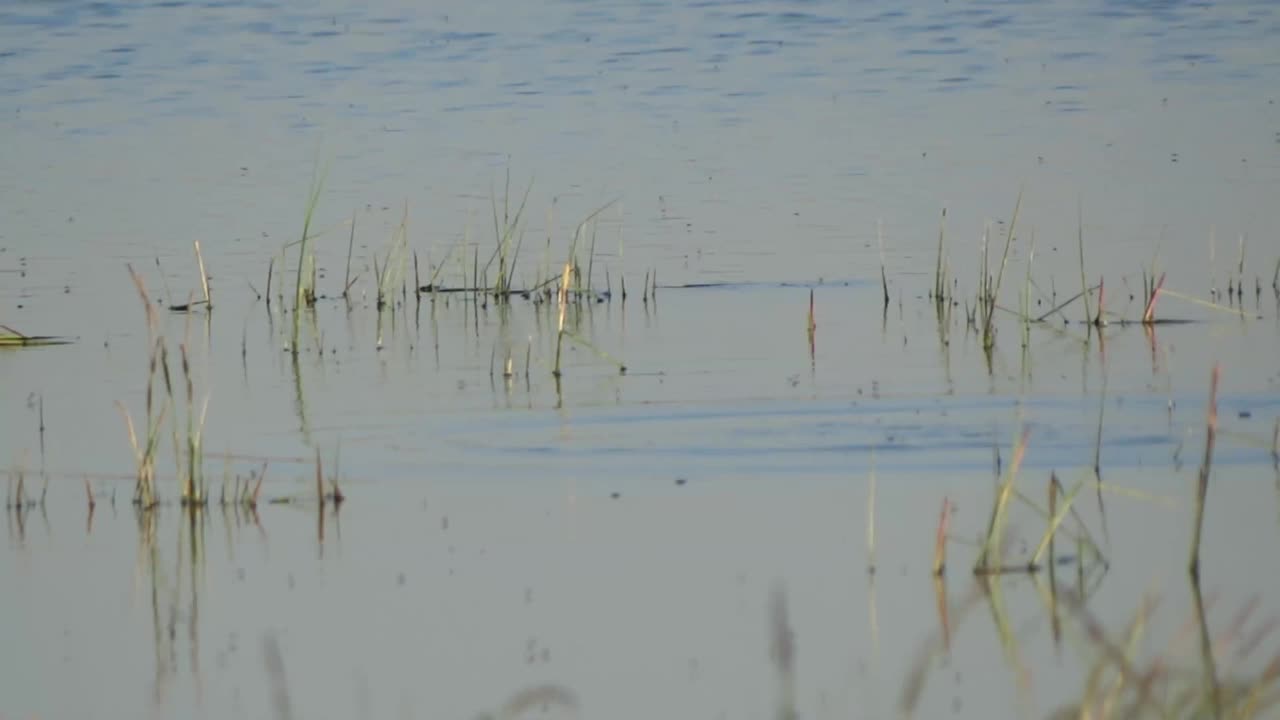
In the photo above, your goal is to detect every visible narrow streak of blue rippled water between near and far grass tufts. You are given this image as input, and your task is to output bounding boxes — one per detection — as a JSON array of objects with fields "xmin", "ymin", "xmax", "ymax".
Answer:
[{"xmin": 357, "ymin": 396, "xmax": 1280, "ymax": 484}]
